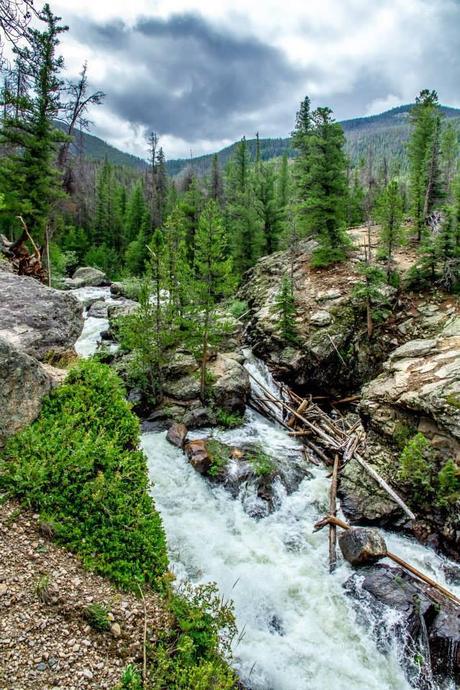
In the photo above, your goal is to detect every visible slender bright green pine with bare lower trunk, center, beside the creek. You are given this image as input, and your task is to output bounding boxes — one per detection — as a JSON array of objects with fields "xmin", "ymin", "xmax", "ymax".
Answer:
[{"xmin": 195, "ymin": 200, "xmax": 234, "ymax": 400}]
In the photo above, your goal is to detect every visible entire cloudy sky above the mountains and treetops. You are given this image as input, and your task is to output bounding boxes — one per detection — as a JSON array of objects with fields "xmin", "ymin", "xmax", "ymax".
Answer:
[{"xmin": 52, "ymin": 0, "xmax": 460, "ymax": 158}]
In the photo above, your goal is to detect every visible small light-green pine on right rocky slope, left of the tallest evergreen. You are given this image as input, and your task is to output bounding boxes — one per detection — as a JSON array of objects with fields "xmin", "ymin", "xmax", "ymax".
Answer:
[{"xmin": 376, "ymin": 180, "xmax": 403, "ymax": 283}]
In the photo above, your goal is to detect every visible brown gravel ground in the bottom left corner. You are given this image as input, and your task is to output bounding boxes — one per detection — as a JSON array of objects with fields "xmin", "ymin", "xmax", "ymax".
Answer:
[{"xmin": 0, "ymin": 502, "xmax": 167, "ymax": 690}]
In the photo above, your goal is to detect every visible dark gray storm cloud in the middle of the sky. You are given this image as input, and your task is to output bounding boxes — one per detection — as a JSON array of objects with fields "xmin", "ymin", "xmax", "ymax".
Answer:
[{"xmin": 74, "ymin": 14, "xmax": 305, "ymax": 141}]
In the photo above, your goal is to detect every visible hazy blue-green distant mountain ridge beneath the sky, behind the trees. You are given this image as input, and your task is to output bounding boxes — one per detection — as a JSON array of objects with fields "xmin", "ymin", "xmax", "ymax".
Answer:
[{"xmin": 69, "ymin": 104, "xmax": 460, "ymax": 177}]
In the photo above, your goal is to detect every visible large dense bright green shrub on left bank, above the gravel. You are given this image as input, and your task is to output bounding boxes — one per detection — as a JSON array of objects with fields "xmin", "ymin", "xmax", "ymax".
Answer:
[{"xmin": 0, "ymin": 360, "xmax": 168, "ymax": 590}]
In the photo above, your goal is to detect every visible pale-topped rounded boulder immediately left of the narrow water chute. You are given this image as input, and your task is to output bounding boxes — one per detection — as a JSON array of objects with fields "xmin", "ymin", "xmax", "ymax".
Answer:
[{"xmin": 209, "ymin": 354, "xmax": 251, "ymax": 413}]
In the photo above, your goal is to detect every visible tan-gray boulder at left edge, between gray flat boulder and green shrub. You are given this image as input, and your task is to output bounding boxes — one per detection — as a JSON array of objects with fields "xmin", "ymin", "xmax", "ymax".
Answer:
[{"xmin": 0, "ymin": 338, "xmax": 54, "ymax": 447}]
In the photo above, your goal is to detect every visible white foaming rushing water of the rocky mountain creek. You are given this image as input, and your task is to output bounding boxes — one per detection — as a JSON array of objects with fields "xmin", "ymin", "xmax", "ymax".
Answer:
[{"xmin": 73, "ymin": 288, "xmax": 460, "ymax": 690}]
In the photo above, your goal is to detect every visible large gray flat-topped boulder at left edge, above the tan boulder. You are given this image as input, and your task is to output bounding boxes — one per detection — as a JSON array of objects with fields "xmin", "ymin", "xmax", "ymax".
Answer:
[{"xmin": 0, "ymin": 270, "xmax": 83, "ymax": 360}]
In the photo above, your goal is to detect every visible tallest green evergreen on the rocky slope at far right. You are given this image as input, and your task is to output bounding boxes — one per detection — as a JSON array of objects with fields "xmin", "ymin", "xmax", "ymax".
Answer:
[{"xmin": 408, "ymin": 89, "xmax": 440, "ymax": 241}]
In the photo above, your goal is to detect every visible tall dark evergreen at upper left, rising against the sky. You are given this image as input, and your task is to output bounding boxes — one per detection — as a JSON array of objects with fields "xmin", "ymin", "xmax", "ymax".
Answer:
[{"xmin": 0, "ymin": 4, "xmax": 67, "ymax": 242}]
